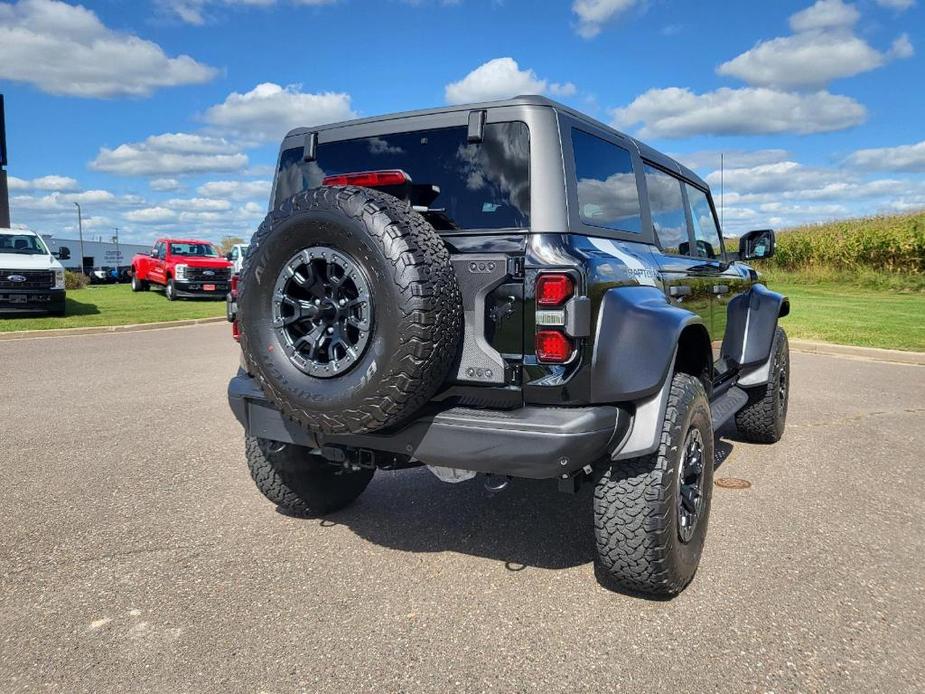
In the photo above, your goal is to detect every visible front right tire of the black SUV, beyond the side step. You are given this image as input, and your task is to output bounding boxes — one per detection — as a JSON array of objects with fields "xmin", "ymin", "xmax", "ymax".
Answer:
[{"xmin": 736, "ymin": 328, "xmax": 790, "ymax": 443}]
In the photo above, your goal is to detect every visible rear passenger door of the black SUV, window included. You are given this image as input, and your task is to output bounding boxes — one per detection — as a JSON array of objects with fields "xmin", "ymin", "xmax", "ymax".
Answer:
[{"xmin": 643, "ymin": 162, "xmax": 713, "ymax": 354}]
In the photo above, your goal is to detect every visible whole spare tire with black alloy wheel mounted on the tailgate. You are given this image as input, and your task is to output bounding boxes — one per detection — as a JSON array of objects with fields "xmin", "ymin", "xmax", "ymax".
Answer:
[{"xmin": 238, "ymin": 186, "xmax": 462, "ymax": 434}]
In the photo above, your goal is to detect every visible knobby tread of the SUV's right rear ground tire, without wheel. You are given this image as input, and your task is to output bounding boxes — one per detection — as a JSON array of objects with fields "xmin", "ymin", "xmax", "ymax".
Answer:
[{"xmin": 594, "ymin": 373, "xmax": 712, "ymax": 596}]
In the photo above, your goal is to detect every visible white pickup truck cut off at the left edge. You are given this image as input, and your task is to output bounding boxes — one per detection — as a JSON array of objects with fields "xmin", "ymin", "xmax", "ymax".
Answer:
[{"xmin": 0, "ymin": 228, "xmax": 70, "ymax": 316}]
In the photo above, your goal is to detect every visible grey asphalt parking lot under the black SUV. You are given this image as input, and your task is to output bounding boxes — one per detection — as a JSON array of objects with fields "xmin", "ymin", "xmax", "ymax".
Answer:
[{"xmin": 0, "ymin": 325, "xmax": 925, "ymax": 692}]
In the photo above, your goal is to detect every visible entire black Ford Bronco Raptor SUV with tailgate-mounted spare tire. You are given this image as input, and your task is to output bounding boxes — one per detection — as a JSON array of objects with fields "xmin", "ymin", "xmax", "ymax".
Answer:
[{"xmin": 228, "ymin": 96, "xmax": 789, "ymax": 595}]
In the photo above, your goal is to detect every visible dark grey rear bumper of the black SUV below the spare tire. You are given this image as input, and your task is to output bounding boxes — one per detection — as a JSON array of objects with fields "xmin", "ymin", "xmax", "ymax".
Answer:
[{"xmin": 228, "ymin": 373, "xmax": 631, "ymax": 479}]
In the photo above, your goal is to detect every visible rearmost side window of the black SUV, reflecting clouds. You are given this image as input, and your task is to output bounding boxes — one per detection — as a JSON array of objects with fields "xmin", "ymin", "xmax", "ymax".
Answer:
[{"xmin": 572, "ymin": 130, "xmax": 642, "ymax": 234}]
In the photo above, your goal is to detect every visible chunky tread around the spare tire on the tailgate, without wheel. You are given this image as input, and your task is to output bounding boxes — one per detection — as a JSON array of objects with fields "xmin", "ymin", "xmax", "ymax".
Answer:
[{"xmin": 238, "ymin": 186, "xmax": 463, "ymax": 434}]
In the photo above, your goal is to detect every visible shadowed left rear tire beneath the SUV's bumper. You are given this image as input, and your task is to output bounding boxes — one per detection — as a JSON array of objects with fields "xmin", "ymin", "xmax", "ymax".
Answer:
[{"xmin": 244, "ymin": 436, "xmax": 375, "ymax": 516}]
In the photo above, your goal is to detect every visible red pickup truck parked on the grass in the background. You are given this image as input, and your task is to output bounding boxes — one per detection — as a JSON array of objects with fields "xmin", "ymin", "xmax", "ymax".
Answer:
[{"xmin": 132, "ymin": 239, "xmax": 231, "ymax": 301}]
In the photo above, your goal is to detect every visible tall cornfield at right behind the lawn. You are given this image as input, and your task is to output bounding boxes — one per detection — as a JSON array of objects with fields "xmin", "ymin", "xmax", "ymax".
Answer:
[{"xmin": 762, "ymin": 212, "xmax": 925, "ymax": 275}]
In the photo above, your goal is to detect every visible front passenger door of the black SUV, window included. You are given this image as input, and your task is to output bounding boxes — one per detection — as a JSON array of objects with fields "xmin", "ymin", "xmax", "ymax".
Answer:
[{"xmin": 684, "ymin": 182, "xmax": 751, "ymax": 378}]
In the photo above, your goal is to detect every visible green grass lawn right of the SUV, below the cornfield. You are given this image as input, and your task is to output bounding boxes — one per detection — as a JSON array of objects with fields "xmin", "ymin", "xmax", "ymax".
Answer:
[{"xmin": 768, "ymin": 281, "xmax": 925, "ymax": 352}]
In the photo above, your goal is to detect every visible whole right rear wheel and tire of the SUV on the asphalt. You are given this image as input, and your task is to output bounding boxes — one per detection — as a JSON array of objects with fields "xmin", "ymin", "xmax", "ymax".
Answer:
[{"xmin": 594, "ymin": 374, "xmax": 713, "ymax": 597}]
